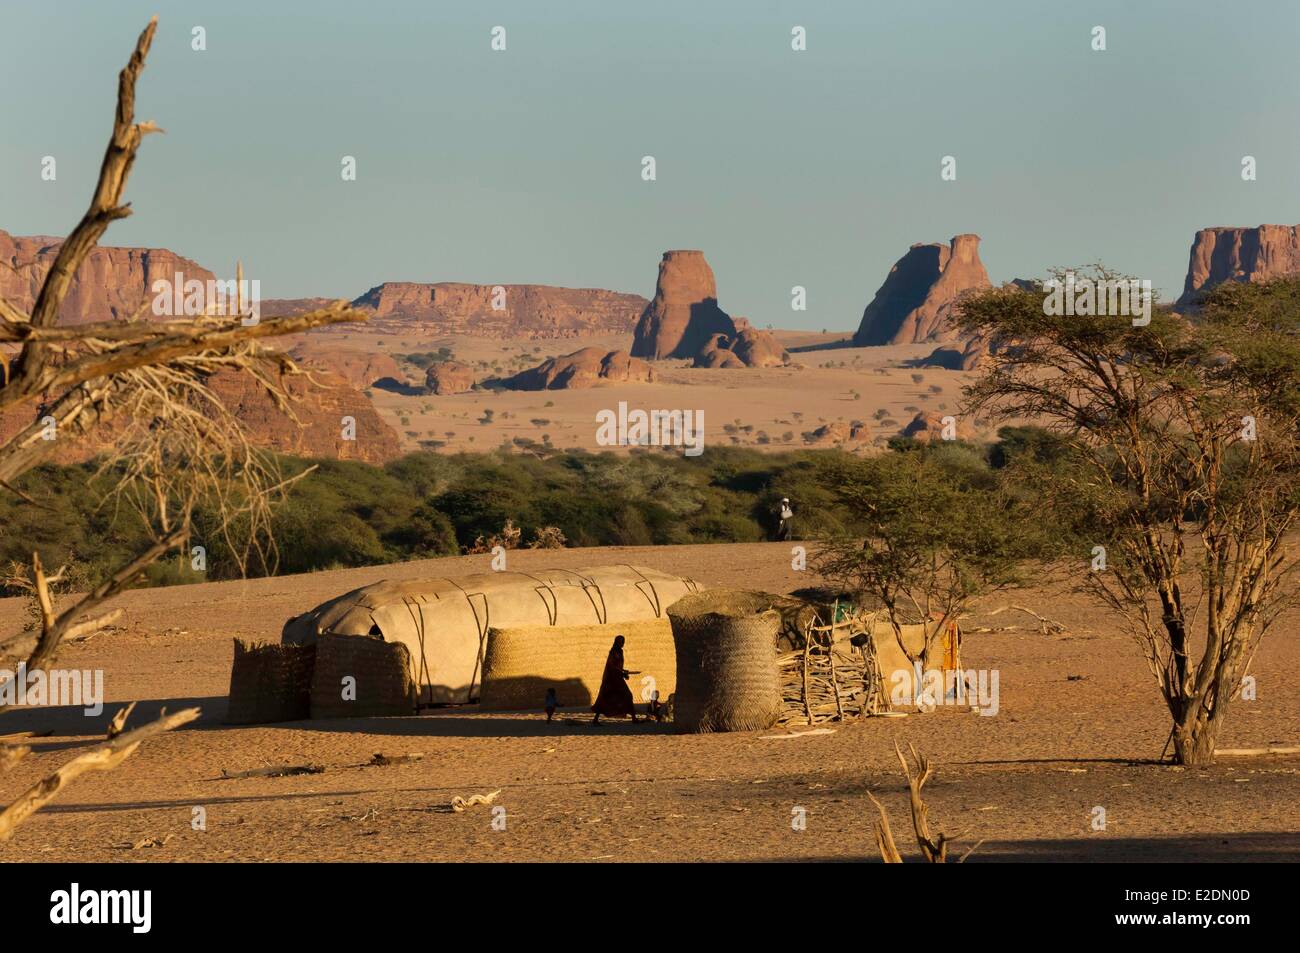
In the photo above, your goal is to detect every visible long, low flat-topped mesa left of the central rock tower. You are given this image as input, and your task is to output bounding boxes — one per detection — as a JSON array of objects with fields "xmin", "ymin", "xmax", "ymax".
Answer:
[{"xmin": 352, "ymin": 281, "xmax": 646, "ymax": 339}]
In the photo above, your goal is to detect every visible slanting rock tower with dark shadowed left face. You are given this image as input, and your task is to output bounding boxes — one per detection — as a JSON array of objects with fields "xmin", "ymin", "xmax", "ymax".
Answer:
[{"xmin": 853, "ymin": 235, "xmax": 992, "ymax": 347}]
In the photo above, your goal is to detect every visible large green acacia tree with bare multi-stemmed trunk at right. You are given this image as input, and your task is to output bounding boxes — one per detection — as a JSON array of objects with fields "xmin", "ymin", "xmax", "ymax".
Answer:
[{"xmin": 961, "ymin": 271, "xmax": 1300, "ymax": 764}]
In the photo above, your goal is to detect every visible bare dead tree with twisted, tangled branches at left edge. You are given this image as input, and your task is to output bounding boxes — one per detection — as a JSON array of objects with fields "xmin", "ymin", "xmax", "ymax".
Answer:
[{"xmin": 0, "ymin": 17, "xmax": 364, "ymax": 691}]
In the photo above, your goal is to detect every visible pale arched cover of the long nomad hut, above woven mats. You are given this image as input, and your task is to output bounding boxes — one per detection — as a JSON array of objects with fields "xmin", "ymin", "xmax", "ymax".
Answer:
[{"xmin": 281, "ymin": 566, "xmax": 702, "ymax": 703}]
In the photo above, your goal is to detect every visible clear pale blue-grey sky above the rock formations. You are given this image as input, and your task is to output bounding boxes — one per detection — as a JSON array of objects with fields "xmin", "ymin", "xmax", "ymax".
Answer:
[{"xmin": 0, "ymin": 0, "xmax": 1300, "ymax": 330}]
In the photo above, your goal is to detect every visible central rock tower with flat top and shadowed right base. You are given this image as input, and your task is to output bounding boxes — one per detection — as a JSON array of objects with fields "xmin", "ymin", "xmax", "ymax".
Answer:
[{"xmin": 632, "ymin": 250, "xmax": 737, "ymax": 360}]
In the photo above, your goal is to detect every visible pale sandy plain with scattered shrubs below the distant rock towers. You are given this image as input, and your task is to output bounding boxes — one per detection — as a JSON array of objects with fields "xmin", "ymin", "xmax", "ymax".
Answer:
[{"xmin": 338, "ymin": 329, "xmax": 975, "ymax": 451}]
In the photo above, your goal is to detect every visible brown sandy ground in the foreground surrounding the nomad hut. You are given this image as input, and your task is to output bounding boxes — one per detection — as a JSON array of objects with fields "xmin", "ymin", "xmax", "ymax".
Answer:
[{"xmin": 0, "ymin": 543, "xmax": 1300, "ymax": 862}]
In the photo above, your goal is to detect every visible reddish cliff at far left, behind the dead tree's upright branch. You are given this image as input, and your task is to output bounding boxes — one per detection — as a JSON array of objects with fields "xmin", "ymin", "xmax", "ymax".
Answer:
[{"xmin": 0, "ymin": 231, "xmax": 213, "ymax": 324}]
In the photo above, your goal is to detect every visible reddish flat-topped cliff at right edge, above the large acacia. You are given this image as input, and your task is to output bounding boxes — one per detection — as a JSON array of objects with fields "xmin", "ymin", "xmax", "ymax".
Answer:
[{"xmin": 1178, "ymin": 225, "xmax": 1300, "ymax": 306}]
